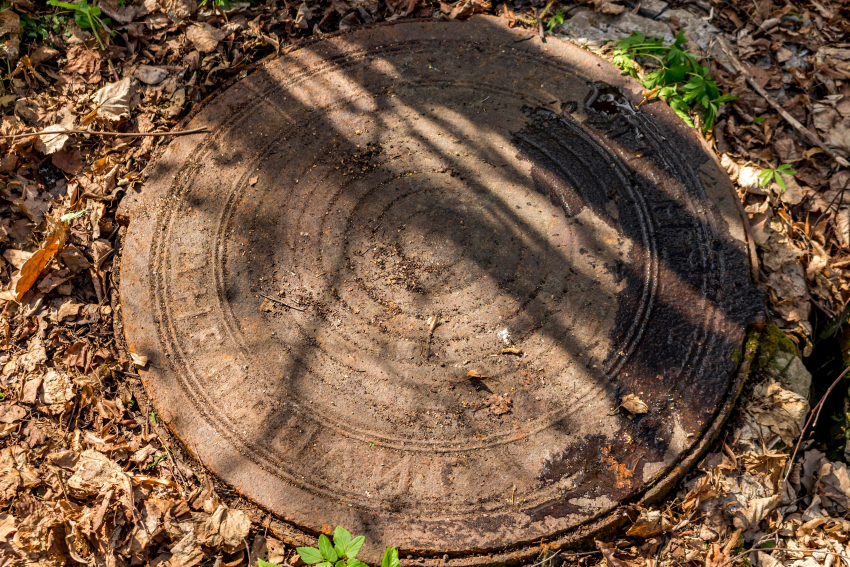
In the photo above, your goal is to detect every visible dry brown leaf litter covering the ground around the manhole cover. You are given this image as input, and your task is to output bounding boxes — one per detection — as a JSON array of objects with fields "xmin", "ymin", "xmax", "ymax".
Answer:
[{"xmin": 0, "ymin": 0, "xmax": 850, "ymax": 567}]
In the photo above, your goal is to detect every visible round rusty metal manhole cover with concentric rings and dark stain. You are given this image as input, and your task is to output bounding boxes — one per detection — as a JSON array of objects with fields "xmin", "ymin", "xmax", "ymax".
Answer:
[{"xmin": 121, "ymin": 17, "xmax": 760, "ymax": 562}]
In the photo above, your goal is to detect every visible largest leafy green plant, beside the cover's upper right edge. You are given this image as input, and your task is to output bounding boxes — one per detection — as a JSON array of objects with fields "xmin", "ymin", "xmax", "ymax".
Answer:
[{"xmin": 612, "ymin": 31, "xmax": 736, "ymax": 132}]
